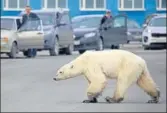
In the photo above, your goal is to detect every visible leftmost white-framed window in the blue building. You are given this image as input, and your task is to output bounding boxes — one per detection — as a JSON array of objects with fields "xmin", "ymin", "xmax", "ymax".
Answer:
[{"xmin": 3, "ymin": 0, "xmax": 29, "ymax": 10}]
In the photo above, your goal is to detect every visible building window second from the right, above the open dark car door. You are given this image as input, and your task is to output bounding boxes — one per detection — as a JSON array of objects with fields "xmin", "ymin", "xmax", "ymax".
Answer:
[{"xmin": 118, "ymin": 0, "xmax": 144, "ymax": 11}]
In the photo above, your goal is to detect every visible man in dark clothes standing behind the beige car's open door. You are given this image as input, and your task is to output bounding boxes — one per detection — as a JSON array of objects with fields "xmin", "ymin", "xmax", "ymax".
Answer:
[{"xmin": 21, "ymin": 6, "xmax": 39, "ymax": 57}]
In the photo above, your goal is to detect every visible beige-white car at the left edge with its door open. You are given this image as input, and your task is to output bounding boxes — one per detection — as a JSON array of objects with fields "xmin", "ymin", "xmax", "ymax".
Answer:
[{"xmin": 1, "ymin": 16, "xmax": 44, "ymax": 58}]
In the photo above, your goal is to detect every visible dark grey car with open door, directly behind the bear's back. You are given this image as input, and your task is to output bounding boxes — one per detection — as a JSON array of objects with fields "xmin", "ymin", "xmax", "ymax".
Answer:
[{"xmin": 72, "ymin": 15, "xmax": 127, "ymax": 54}]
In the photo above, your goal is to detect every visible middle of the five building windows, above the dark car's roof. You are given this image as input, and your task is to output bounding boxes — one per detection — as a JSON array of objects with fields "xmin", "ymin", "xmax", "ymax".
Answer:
[{"xmin": 80, "ymin": 0, "xmax": 106, "ymax": 10}]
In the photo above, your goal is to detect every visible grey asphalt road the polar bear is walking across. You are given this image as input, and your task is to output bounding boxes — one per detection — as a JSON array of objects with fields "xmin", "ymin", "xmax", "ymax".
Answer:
[{"xmin": 1, "ymin": 44, "xmax": 166, "ymax": 112}]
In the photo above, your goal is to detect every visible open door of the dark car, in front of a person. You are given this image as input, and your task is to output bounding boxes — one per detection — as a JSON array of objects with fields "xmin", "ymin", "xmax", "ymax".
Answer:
[{"xmin": 103, "ymin": 15, "xmax": 127, "ymax": 46}]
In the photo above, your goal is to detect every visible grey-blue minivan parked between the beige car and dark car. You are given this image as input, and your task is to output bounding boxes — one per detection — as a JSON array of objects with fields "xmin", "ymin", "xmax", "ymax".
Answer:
[{"xmin": 20, "ymin": 9, "xmax": 74, "ymax": 56}]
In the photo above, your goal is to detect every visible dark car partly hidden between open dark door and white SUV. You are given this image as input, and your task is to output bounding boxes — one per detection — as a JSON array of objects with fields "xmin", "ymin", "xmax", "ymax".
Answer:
[{"xmin": 127, "ymin": 19, "xmax": 143, "ymax": 43}]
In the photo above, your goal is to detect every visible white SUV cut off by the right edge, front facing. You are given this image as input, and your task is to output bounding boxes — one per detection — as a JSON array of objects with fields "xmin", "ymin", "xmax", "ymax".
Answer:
[{"xmin": 142, "ymin": 14, "xmax": 167, "ymax": 50}]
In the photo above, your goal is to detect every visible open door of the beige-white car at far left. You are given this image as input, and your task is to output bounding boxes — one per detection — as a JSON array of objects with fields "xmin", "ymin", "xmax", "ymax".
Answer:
[{"xmin": 17, "ymin": 20, "xmax": 44, "ymax": 50}]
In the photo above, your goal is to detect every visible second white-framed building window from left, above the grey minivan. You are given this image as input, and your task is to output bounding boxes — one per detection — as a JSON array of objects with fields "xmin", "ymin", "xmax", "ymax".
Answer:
[{"xmin": 42, "ymin": 0, "xmax": 68, "ymax": 9}]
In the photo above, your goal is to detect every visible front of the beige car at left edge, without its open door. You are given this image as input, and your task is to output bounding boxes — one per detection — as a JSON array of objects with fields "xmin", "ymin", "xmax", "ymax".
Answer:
[{"xmin": 1, "ymin": 16, "xmax": 21, "ymax": 58}]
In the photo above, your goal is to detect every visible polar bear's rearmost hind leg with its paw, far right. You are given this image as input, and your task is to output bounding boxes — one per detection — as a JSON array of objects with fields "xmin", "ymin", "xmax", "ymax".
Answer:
[{"xmin": 137, "ymin": 72, "xmax": 160, "ymax": 103}]
